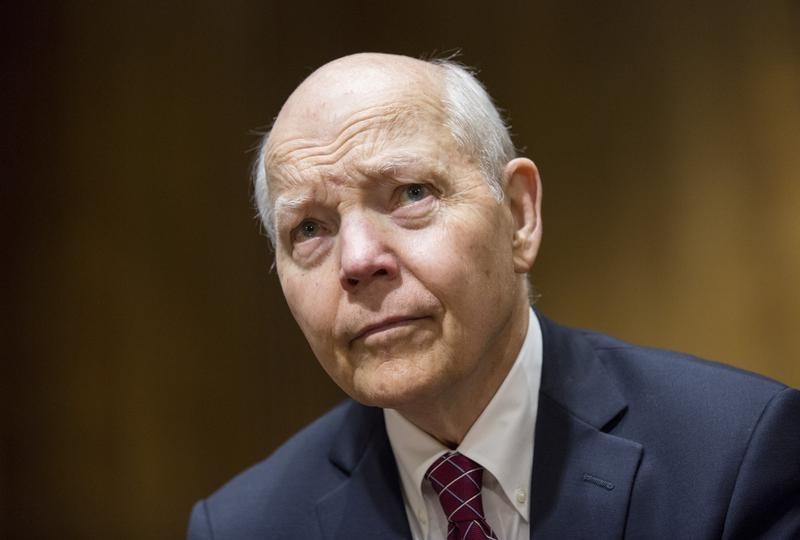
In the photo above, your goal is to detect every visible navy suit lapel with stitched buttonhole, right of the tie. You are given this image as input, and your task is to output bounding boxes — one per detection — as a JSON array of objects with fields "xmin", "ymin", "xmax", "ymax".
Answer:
[{"xmin": 531, "ymin": 317, "xmax": 642, "ymax": 538}]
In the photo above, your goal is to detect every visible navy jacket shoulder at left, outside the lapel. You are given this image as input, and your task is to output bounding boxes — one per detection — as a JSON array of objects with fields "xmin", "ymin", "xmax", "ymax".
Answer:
[{"xmin": 201, "ymin": 401, "xmax": 358, "ymax": 539}]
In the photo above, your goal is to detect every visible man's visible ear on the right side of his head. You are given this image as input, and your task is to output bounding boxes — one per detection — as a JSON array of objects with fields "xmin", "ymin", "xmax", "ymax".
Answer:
[{"xmin": 503, "ymin": 158, "xmax": 542, "ymax": 274}]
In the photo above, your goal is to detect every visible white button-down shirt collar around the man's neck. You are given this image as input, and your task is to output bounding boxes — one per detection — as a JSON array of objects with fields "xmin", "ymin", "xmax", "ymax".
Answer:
[{"xmin": 384, "ymin": 309, "xmax": 542, "ymax": 521}]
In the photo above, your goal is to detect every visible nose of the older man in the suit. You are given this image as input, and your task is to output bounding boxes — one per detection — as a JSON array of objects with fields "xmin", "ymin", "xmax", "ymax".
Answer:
[{"xmin": 339, "ymin": 216, "xmax": 399, "ymax": 292}]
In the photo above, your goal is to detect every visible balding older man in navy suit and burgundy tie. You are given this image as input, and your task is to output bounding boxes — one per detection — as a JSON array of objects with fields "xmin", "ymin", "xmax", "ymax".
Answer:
[{"xmin": 189, "ymin": 54, "xmax": 800, "ymax": 539}]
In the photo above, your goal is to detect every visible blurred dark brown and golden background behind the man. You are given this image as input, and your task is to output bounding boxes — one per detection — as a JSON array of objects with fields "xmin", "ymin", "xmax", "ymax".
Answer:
[{"xmin": 0, "ymin": 0, "xmax": 800, "ymax": 539}]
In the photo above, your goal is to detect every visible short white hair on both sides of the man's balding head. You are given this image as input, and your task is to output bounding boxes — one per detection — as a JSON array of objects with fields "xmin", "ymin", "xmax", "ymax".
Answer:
[{"xmin": 252, "ymin": 59, "xmax": 516, "ymax": 246}]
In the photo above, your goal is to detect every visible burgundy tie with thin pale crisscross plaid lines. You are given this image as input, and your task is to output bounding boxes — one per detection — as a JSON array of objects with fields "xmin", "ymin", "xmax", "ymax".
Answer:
[{"xmin": 425, "ymin": 452, "xmax": 497, "ymax": 540}]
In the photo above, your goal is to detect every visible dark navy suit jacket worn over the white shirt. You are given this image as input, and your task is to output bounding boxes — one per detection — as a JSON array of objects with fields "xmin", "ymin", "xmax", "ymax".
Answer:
[{"xmin": 189, "ymin": 317, "xmax": 800, "ymax": 540}]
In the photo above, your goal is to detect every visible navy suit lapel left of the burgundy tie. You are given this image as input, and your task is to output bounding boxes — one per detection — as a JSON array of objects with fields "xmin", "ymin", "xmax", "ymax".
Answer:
[{"xmin": 317, "ymin": 403, "xmax": 411, "ymax": 540}]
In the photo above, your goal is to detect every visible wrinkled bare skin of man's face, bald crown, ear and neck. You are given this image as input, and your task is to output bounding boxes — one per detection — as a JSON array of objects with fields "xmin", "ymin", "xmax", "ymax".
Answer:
[{"xmin": 267, "ymin": 54, "xmax": 541, "ymax": 445}]
